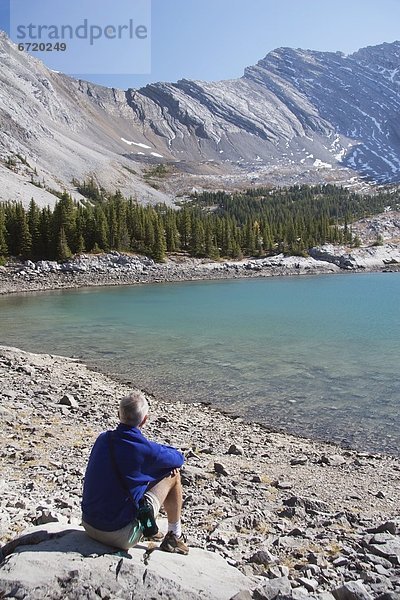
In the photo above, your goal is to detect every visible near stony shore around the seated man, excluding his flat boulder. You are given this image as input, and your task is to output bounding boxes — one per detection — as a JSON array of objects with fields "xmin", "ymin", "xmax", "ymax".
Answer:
[{"xmin": 0, "ymin": 346, "xmax": 400, "ymax": 597}]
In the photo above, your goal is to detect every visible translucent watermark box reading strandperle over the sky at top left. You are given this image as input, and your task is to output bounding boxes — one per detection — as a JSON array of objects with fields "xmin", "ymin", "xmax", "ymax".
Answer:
[{"xmin": 9, "ymin": 0, "xmax": 151, "ymax": 75}]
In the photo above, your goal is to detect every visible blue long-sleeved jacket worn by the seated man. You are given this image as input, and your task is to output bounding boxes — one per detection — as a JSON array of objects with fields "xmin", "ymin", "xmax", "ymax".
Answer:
[{"xmin": 82, "ymin": 424, "xmax": 184, "ymax": 531}]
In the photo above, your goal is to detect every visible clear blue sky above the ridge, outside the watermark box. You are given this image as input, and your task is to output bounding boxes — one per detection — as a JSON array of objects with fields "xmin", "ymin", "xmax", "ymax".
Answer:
[{"xmin": 0, "ymin": 0, "xmax": 400, "ymax": 88}]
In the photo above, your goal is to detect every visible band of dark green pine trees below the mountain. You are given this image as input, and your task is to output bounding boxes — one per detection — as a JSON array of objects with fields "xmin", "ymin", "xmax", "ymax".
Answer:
[{"xmin": 0, "ymin": 184, "xmax": 398, "ymax": 261}]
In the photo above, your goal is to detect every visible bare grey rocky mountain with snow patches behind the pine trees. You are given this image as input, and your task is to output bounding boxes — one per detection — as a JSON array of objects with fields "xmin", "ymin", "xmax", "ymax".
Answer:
[{"xmin": 0, "ymin": 33, "xmax": 400, "ymax": 202}]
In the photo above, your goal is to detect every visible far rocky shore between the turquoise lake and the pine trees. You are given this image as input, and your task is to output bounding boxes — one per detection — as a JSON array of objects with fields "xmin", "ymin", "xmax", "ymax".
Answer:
[{"xmin": 0, "ymin": 243, "xmax": 400, "ymax": 294}]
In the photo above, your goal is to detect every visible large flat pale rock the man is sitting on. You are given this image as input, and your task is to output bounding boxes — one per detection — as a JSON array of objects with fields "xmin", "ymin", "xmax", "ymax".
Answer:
[{"xmin": 0, "ymin": 525, "xmax": 254, "ymax": 600}]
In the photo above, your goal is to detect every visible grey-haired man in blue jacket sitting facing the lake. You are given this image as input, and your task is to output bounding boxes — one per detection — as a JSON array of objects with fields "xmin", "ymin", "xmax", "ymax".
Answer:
[{"xmin": 82, "ymin": 391, "xmax": 189, "ymax": 554}]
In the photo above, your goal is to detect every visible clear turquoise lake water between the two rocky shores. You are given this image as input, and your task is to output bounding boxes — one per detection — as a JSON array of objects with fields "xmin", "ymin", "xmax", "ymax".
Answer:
[{"xmin": 0, "ymin": 273, "xmax": 400, "ymax": 454}]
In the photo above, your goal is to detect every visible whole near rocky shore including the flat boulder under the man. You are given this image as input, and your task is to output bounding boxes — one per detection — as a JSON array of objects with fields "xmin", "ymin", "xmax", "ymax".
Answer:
[{"xmin": 0, "ymin": 344, "xmax": 400, "ymax": 600}]
